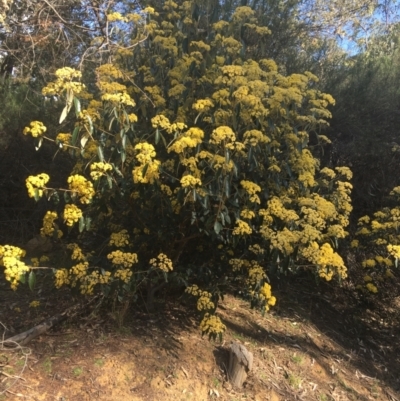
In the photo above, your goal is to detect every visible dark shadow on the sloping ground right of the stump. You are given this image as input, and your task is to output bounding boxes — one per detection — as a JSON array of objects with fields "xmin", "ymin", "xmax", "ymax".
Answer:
[{"xmin": 219, "ymin": 277, "xmax": 400, "ymax": 401}]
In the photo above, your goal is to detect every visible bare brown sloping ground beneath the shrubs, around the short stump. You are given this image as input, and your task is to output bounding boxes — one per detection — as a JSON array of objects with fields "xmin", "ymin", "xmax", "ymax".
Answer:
[{"xmin": 0, "ymin": 279, "xmax": 400, "ymax": 401}]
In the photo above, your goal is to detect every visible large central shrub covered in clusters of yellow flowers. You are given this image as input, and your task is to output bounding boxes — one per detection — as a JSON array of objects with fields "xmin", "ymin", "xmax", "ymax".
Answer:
[{"xmin": 3, "ymin": 0, "xmax": 351, "ymax": 337}]
